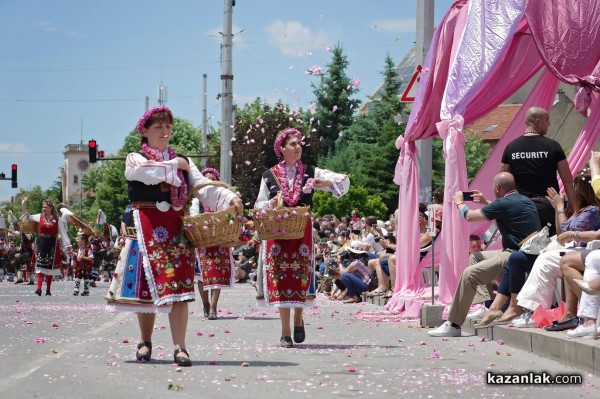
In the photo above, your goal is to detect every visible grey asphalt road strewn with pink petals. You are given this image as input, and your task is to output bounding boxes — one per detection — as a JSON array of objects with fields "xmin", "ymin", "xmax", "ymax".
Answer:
[{"xmin": 0, "ymin": 281, "xmax": 600, "ymax": 399}]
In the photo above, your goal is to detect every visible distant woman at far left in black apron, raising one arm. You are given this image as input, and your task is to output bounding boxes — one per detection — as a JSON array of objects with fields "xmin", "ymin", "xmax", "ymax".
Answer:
[{"xmin": 21, "ymin": 197, "xmax": 71, "ymax": 296}]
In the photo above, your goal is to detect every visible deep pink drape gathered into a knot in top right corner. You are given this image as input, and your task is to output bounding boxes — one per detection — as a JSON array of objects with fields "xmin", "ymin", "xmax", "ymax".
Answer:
[{"xmin": 525, "ymin": 0, "xmax": 600, "ymax": 115}]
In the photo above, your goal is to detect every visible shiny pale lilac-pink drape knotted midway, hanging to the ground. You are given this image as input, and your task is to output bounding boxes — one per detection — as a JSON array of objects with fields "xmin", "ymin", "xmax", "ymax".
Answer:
[{"xmin": 437, "ymin": 0, "xmax": 525, "ymax": 304}]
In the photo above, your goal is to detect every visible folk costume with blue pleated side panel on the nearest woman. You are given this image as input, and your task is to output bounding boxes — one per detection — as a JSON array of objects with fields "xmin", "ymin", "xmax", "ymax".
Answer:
[{"xmin": 107, "ymin": 151, "xmax": 235, "ymax": 313}]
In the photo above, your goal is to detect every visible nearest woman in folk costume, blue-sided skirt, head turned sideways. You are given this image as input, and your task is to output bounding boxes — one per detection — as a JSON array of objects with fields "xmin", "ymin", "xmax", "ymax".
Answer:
[{"xmin": 107, "ymin": 106, "xmax": 242, "ymax": 366}]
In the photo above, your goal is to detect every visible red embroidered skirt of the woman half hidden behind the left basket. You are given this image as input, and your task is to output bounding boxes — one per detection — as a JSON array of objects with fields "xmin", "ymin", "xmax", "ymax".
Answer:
[{"xmin": 198, "ymin": 247, "xmax": 233, "ymax": 290}]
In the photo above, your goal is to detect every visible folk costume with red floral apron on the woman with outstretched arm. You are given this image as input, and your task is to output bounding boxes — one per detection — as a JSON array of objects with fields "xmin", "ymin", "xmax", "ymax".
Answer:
[{"xmin": 255, "ymin": 161, "xmax": 350, "ymax": 308}]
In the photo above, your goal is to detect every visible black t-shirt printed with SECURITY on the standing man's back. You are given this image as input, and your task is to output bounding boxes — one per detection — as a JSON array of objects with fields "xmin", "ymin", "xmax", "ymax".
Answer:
[{"xmin": 502, "ymin": 136, "xmax": 566, "ymax": 197}]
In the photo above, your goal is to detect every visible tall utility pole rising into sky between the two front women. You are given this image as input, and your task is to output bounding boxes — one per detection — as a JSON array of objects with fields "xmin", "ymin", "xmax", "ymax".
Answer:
[{"xmin": 219, "ymin": 0, "xmax": 235, "ymax": 183}]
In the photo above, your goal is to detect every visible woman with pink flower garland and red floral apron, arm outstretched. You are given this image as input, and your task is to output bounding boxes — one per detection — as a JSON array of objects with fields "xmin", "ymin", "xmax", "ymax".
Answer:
[{"xmin": 255, "ymin": 128, "xmax": 350, "ymax": 348}]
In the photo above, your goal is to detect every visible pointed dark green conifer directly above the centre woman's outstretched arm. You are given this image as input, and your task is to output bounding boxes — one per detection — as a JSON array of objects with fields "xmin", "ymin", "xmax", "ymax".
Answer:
[{"xmin": 309, "ymin": 44, "xmax": 360, "ymax": 155}]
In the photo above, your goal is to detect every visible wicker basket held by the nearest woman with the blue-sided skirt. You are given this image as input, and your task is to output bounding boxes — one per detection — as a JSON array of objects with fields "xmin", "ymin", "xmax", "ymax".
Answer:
[{"xmin": 182, "ymin": 207, "xmax": 242, "ymax": 248}]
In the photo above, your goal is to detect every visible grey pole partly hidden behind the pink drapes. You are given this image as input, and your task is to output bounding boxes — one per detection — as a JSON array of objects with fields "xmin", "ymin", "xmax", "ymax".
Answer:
[{"xmin": 415, "ymin": 0, "xmax": 434, "ymax": 203}]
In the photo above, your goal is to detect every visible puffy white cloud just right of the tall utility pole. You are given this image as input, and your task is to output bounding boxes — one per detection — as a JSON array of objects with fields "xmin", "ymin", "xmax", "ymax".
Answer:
[{"xmin": 265, "ymin": 20, "xmax": 327, "ymax": 55}]
